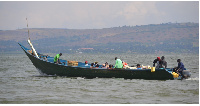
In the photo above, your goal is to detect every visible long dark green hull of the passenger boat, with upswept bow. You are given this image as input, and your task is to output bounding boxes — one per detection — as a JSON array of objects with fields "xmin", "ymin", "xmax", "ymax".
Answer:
[{"xmin": 19, "ymin": 44, "xmax": 174, "ymax": 80}]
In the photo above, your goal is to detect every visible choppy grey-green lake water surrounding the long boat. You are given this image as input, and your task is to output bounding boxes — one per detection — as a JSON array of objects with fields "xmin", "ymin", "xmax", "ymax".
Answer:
[{"xmin": 0, "ymin": 53, "xmax": 199, "ymax": 104}]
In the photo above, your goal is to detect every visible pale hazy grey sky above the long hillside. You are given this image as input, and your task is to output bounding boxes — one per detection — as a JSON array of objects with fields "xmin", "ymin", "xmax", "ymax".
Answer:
[{"xmin": 0, "ymin": 1, "xmax": 199, "ymax": 30}]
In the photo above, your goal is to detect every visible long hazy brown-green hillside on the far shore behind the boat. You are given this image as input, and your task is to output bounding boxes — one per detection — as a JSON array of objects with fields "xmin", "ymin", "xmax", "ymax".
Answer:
[{"xmin": 0, "ymin": 23, "xmax": 199, "ymax": 54}]
